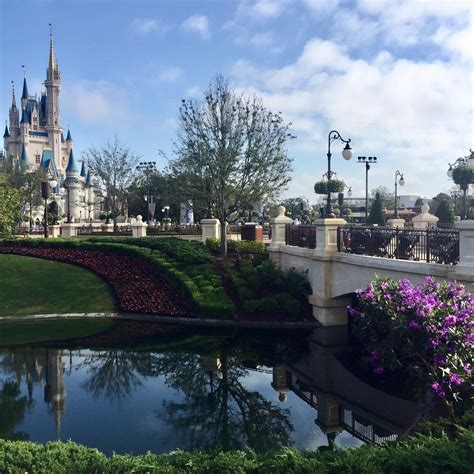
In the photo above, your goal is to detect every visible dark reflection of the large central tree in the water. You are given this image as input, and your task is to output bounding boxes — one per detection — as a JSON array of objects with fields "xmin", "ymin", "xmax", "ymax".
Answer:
[{"xmin": 154, "ymin": 351, "xmax": 293, "ymax": 451}]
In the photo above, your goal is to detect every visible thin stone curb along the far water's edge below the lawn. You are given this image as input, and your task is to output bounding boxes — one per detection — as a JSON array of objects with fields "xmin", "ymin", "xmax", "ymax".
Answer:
[{"xmin": 0, "ymin": 313, "xmax": 321, "ymax": 329}]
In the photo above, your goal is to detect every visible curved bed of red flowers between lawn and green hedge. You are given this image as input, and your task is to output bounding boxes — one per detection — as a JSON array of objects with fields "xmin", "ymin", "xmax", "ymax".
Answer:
[{"xmin": 0, "ymin": 247, "xmax": 189, "ymax": 316}]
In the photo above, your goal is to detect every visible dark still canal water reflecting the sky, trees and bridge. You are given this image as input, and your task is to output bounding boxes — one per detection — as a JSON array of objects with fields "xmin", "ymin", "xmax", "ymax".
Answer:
[{"xmin": 0, "ymin": 329, "xmax": 419, "ymax": 454}]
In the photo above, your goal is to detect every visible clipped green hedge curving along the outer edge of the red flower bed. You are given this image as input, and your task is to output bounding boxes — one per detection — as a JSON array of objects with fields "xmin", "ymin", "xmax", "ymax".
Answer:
[{"xmin": 0, "ymin": 239, "xmax": 235, "ymax": 319}]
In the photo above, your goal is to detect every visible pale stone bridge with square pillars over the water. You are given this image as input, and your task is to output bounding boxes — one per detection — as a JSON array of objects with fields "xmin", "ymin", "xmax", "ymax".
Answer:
[{"xmin": 269, "ymin": 208, "xmax": 474, "ymax": 326}]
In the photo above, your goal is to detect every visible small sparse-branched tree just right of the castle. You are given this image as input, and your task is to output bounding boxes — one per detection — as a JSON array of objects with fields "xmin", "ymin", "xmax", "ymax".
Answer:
[{"xmin": 87, "ymin": 137, "xmax": 138, "ymax": 227}]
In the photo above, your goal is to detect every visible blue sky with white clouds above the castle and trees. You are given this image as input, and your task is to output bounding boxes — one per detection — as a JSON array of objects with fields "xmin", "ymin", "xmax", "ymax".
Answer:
[{"xmin": 0, "ymin": 0, "xmax": 474, "ymax": 202}]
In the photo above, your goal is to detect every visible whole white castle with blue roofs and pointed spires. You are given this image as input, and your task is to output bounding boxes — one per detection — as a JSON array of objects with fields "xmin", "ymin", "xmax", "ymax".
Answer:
[{"xmin": 3, "ymin": 31, "xmax": 100, "ymax": 222}]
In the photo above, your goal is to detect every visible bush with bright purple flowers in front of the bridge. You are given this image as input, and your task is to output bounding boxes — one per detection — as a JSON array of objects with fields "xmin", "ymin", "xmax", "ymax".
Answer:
[{"xmin": 348, "ymin": 277, "xmax": 474, "ymax": 401}]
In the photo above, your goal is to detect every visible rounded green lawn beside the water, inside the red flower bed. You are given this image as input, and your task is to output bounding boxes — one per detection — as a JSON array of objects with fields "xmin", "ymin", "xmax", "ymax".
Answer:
[{"xmin": 0, "ymin": 255, "xmax": 116, "ymax": 317}]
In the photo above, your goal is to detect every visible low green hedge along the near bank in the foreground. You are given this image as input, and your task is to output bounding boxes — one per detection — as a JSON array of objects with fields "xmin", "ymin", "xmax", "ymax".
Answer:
[{"xmin": 0, "ymin": 428, "xmax": 474, "ymax": 474}]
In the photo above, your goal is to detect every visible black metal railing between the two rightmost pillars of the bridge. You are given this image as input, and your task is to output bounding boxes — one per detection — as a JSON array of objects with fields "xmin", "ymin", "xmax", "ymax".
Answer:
[{"xmin": 337, "ymin": 226, "xmax": 459, "ymax": 265}]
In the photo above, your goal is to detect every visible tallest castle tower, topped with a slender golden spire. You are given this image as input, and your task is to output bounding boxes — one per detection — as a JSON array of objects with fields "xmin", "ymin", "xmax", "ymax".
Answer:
[{"xmin": 44, "ymin": 25, "xmax": 64, "ymax": 174}]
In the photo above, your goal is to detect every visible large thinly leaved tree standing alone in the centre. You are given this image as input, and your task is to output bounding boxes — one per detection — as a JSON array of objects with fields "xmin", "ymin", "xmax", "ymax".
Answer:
[{"xmin": 169, "ymin": 75, "xmax": 294, "ymax": 255}]
